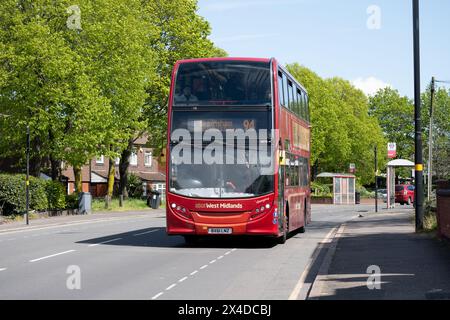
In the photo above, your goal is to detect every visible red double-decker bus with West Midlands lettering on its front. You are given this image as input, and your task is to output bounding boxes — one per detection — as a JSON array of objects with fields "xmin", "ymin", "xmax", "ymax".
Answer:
[{"xmin": 166, "ymin": 58, "xmax": 311, "ymax": 243}]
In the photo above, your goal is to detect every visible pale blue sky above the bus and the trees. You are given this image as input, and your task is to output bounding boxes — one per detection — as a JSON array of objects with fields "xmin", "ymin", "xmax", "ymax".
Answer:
[{"xmin": 198, "ymin": 0, "xmax": 450, "ymax": 98}]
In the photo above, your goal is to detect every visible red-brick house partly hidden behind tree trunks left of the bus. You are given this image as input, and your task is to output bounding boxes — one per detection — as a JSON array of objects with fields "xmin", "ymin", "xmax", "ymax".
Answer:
[{"xmin": 62, "ymin": 137, "xmax": 166, "ymax": 198}]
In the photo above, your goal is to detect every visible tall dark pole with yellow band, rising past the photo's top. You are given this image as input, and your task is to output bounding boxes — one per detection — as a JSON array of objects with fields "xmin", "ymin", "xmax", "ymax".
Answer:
[{"xmin": 413, "ymin": 0, "xmax": 424, "ymax": 232}]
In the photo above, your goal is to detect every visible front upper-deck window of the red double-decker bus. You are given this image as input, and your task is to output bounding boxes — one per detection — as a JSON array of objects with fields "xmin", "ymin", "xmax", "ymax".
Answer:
[{"xmin": 173, "ymin": 61, "xmax": 272, "ymax": 106}]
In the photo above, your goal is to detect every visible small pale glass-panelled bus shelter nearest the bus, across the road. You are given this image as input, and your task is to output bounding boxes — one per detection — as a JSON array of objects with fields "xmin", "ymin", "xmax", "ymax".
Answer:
[{"xmin": 317, "ymin": 172, "xmax": 355, "ymax": 204}]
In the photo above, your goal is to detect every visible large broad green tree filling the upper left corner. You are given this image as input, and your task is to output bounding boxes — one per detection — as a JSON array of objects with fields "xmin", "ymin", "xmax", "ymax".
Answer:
[{"xmin": 0, "ymin": 0, "xmax": 110, "ymax": 190}]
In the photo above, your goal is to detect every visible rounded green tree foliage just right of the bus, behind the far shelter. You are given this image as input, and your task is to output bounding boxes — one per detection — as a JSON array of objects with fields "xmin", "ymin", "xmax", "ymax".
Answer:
[{"xmin": 287, "ymin": 63, "xmax": 385, "ymax": 183}]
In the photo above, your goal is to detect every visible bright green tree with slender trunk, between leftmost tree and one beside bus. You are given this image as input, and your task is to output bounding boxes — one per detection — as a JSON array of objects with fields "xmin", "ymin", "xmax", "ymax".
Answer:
[{"xmin": 67, "ymin": 0, "xmax": 157, "ymax": 205}]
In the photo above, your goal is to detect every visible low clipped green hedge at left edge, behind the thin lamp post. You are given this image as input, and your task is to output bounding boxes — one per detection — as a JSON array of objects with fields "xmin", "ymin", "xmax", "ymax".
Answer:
[{"xmin": 0, "ymin": 174, "xmax": 66, "ymax": 215}]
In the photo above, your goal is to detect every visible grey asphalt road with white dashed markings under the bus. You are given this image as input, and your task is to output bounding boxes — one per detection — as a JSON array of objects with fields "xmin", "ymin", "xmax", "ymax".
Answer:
[{"xmin": 0, "ymin": 205, "xmax": 372, "ymax": 300}]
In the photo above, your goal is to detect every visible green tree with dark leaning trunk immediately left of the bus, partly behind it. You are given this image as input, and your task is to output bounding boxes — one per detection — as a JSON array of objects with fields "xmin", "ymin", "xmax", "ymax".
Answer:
[{"xmin": 119, "ymin": 0, "xmax": 226, "ymax": 196}]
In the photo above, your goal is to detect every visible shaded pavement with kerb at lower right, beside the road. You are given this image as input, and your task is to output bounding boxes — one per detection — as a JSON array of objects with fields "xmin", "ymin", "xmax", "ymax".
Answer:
[{"xmin": 308, "ymin": 209, "xmax": 450, "ymax": 300}]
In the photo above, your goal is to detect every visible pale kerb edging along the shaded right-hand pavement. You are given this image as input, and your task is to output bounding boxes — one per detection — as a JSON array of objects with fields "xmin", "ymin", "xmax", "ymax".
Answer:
[{"xmin": 307, "ymin": 222, "xmax": 346, "ymax": 300}]
